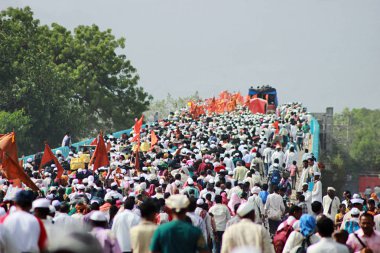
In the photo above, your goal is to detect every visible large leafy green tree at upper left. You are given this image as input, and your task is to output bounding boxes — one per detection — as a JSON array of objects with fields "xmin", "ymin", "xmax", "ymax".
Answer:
[{"xmin": 0, "ymin": 7, "xmax": 152, "ymax": 153}]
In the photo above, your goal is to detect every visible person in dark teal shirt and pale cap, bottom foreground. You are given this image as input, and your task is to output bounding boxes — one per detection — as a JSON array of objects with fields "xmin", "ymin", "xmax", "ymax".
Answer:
[{"xmin": 150, "ymin": 194, "xmax": 208, "ymax": 253}]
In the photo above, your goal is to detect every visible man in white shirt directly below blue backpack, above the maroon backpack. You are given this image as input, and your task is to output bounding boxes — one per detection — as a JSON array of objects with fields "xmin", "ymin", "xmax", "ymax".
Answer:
[{"xmin": 265, "ymin": 185, "xmax": 285, "ymax": 235}]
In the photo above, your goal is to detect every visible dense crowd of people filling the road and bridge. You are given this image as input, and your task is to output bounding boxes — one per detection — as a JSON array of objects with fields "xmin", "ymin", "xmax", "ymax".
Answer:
[{"xmin": 0, "ymin": 103, "xmax": 380, "ymax": 253}]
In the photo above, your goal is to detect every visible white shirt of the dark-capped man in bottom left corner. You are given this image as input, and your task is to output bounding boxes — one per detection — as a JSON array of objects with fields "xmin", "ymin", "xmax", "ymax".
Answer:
[{"xmin": 3, "ymin": 210, "xmax": 41, "ymax": 253}]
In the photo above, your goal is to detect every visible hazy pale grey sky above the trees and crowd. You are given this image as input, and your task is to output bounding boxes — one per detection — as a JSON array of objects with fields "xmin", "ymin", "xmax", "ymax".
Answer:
[{"xmin": 0, "ymin": 0, "xmax": 380, "ymax": 111}]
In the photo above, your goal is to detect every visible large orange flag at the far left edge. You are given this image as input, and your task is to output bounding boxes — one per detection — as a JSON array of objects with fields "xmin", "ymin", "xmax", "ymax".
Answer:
[{"xmin": 0, "ymin": 132, "xmax": 39, "ymax": 191}]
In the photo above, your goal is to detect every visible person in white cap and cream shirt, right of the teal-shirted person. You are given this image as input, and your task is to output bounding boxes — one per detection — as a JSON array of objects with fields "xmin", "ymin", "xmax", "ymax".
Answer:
[{"xmin": 221, "ymin": 202, "xmax": 274, "ymax": 253}]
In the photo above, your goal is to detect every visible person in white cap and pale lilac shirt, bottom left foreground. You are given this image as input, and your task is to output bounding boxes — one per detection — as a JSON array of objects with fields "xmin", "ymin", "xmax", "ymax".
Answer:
[{"xmin": 90, "ymin": 211, "xmax": 121, "ymax": 253}]
